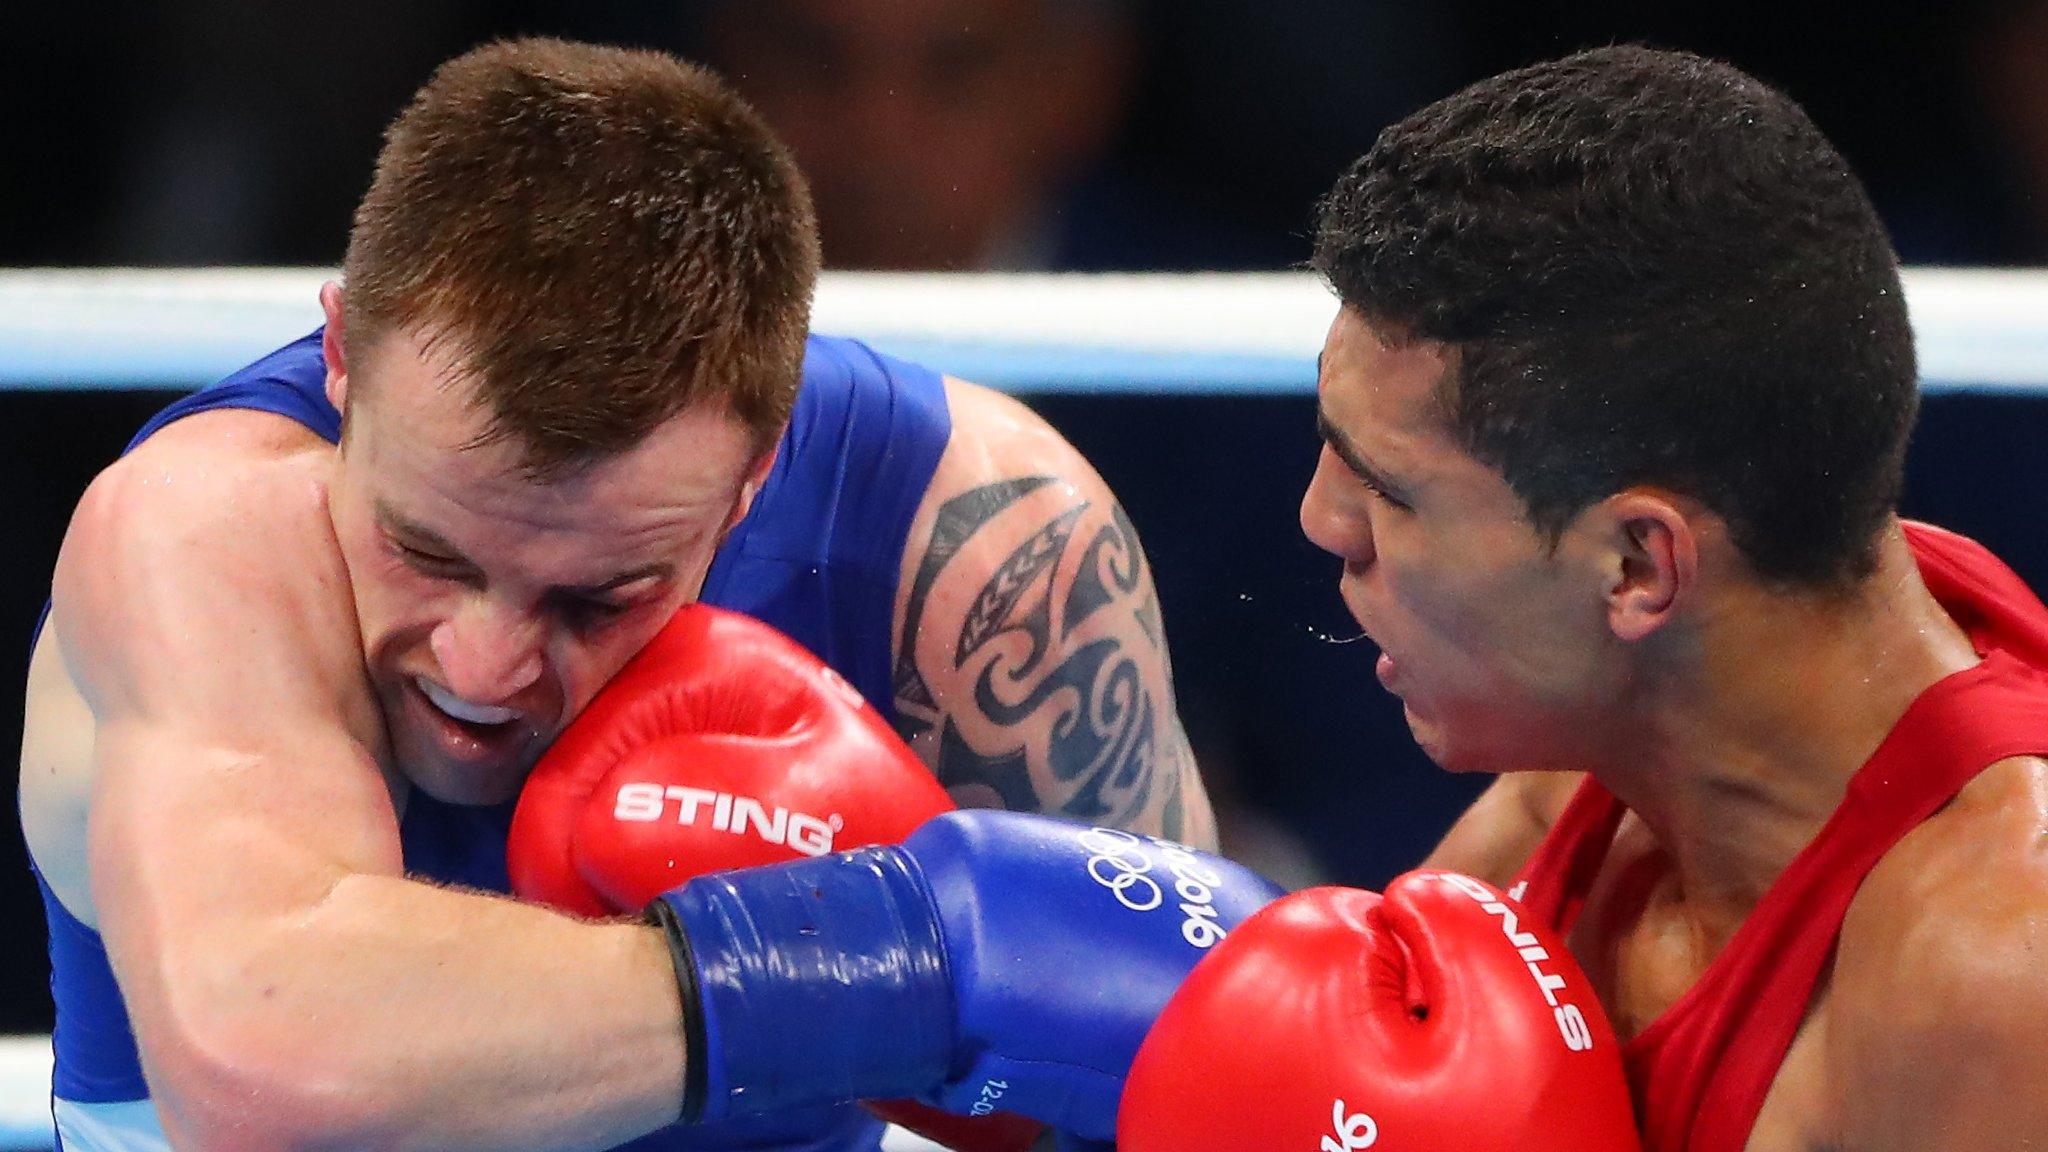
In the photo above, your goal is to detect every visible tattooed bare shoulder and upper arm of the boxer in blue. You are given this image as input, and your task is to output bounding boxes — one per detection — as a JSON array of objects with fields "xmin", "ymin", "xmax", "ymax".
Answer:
[{"xmin": 893, "ymin": 379, "xmax": 1212, "ymax": 845}]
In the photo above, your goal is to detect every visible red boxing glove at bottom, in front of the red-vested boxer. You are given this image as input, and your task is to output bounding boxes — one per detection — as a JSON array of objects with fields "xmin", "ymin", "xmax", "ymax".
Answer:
[{"xmin": 1116, "ymin": 871, "xmax": 1640, "ymax": 1152}]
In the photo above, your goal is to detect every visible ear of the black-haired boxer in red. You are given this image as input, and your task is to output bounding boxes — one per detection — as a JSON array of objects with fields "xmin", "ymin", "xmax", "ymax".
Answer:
[{"xmin": 1599, "ymin": 488, "xmax": 1700, "ymax": 642}]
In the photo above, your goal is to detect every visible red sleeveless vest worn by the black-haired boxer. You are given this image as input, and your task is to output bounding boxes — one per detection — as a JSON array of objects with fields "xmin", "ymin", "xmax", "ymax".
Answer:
[{"xmin": 1518, "ymin": 523, "xmax": 2048, "ymax": 1152}]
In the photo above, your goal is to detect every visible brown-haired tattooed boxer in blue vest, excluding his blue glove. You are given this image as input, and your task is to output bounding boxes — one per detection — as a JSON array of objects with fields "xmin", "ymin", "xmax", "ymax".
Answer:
[{"xmin": 20, "ymin": 41, "xmax": 1212, "ymax": 1150}]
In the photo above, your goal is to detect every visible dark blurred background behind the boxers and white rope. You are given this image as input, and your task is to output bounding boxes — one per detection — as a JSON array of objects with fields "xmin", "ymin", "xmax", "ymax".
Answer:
[{"xmin": 0, "ymin": 0, "xmax": 2048, "ymax": 1031}]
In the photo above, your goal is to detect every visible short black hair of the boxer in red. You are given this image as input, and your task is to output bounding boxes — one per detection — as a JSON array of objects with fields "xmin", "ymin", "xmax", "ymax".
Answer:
[{"xmin": 1315, "ymin": 47, "xmax": 1919, "ymax": 586}]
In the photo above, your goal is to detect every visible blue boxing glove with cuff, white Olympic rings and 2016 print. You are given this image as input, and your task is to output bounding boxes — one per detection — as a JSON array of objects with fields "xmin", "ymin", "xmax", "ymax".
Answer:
[{"xmin": 649, "ymin": 812, "xmax": 1280, "ymax": 1142}]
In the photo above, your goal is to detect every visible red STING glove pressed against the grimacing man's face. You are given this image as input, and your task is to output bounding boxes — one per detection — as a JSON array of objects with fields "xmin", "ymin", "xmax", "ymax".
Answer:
[{"xmin": 506, "ymin": 605, "xmax": 1038, "ymax": 1152}]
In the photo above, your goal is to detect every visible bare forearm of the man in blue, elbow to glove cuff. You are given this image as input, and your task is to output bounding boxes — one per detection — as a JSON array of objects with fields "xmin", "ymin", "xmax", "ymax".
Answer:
[{"xmin": 152, "ymin": 875, "xmax": 682, "ymax": 1152}]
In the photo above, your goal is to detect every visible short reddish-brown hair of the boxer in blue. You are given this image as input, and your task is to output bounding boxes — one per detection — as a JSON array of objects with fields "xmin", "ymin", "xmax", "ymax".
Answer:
[{"xmin": 342, "ymin": 39, "xmax": 819, "ymax": 480}]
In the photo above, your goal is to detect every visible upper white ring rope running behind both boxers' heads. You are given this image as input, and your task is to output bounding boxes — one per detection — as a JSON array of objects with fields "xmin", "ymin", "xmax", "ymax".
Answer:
[{"xmin": 0, "ymin": 269, "xmax": 2048, "ymax": 394}]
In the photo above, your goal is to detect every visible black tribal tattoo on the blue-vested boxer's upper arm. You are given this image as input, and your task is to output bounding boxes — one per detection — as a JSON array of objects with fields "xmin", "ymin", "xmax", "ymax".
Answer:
[{"xmin": 893, "ymin": 476, "xmax": 1190, "ymax": 838}]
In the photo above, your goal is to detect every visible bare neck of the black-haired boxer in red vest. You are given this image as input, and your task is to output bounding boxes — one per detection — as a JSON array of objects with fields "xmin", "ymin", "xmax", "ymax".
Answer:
[{"xmin": 1595, "ymin": 525, "xmax": 1976, "ymax": 927}]
